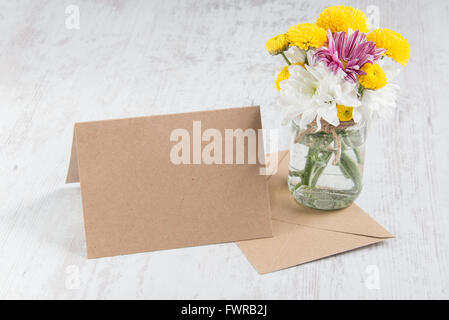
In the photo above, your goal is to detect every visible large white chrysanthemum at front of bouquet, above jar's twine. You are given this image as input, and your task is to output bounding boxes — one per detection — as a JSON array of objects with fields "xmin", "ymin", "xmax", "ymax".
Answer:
[{"xmin": 280, "ymin": 60, "xmax": 360, "ymax": 128}]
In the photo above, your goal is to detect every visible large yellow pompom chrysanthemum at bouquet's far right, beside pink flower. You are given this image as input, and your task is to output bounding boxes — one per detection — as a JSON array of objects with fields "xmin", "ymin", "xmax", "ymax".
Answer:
[{"xmin": 366, "ymin": 28, "xmax": 410, "ymax": 66}]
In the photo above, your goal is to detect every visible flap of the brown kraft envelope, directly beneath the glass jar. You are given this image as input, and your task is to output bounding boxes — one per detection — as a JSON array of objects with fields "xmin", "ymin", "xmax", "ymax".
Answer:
[{"xmin": 269, "ymin": 154, "xmax": 393, "ymax": 238}]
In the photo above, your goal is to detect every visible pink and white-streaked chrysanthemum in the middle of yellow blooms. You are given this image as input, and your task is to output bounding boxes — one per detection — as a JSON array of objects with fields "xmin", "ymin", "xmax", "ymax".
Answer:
[{"xmin": 313, "ymin": 30, "xmax": 385, "ymax": 82}]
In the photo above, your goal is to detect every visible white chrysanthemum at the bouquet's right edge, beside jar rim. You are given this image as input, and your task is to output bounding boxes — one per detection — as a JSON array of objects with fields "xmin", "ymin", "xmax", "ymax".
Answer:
[{"xmin": 353, "ymin": 83, "xmax": 400, "ymax": 122}]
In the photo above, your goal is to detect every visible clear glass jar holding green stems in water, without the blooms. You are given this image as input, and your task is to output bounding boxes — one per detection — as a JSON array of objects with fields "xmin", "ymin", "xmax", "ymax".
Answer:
[{"xmin": 288, "ymin": 117, "xmax": 367, "ymax": 210}]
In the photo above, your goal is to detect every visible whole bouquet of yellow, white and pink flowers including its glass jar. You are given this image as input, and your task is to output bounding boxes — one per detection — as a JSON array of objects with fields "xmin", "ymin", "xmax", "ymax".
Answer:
[{"xmin": 266, "ymin": 6, "xmax": 410, "ymax": 210}]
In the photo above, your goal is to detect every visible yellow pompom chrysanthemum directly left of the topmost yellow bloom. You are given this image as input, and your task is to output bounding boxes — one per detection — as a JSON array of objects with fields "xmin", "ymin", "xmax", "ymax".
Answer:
[{"xmin": 287, "ymin": 23, "xmax": 327, "ymax": 50}]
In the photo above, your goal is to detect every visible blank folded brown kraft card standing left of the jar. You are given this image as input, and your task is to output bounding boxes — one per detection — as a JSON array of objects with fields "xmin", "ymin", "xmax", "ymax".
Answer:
[{"xmin": 66, "ymin": 107, "xmax": 272, "ymax": 258}]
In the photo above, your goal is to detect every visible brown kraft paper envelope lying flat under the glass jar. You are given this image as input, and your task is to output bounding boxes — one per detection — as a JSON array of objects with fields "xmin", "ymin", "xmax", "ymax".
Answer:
[{"xmin": 237, "ymin": 152, "xmax": 393, "ymax": 274}]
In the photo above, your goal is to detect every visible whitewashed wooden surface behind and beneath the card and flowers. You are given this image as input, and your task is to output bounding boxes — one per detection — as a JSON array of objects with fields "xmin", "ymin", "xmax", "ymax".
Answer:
[{"xmin": 0, "ymin": 0, "xmax": 449, "ymax": 299}]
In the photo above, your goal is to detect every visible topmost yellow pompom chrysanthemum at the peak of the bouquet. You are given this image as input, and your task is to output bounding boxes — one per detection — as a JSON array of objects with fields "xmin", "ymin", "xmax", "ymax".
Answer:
[{"xmin": 316, "ymin": 6, "xmax": 369, "ymax": 32}]
